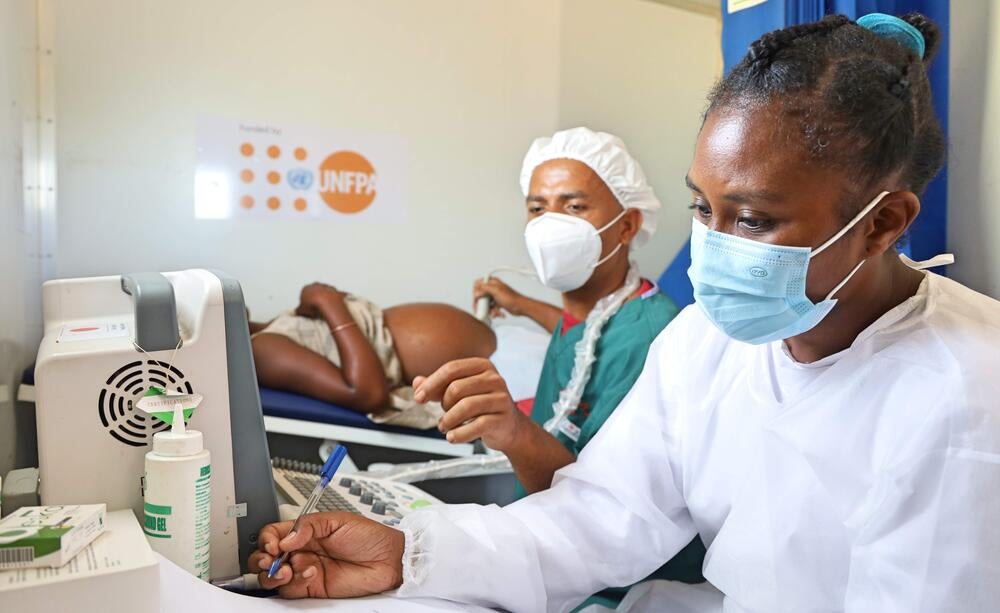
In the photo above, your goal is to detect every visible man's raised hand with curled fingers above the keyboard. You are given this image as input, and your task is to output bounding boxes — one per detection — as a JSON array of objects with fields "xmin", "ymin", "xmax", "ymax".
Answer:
[{"xmin": 413, "ymin": 358, "xmax": 529, "ymax": 452}]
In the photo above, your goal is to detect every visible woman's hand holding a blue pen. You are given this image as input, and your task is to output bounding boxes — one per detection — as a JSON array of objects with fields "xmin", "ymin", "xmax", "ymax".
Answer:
[{"xmin": 247, "ymin": 512, "xmax": 404, "ymax": 598}]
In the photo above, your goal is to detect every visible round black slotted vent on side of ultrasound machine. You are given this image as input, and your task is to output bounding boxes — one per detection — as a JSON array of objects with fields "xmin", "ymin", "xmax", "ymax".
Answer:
[{"xmin": 97, "ymin": 360, "xmax": 194, "ymax": 447}]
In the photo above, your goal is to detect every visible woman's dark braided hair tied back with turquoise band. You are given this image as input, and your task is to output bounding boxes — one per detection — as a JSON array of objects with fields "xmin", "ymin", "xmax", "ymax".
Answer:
[{"xmin": 705, "ymin": 13, "xmax": 945, "ymax": 218}]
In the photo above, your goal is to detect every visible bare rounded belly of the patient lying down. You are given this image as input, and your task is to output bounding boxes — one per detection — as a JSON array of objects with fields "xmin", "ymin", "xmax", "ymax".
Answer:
[{"xmin": 383, "ymin": 303, "xmax": 496, "ymax": 383}]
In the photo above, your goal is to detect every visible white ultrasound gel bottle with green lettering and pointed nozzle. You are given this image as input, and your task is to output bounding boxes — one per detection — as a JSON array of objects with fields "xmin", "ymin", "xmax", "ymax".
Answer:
[{"xmin": 142, "ymin": 403, "xmax": 212, "ymax": 581}]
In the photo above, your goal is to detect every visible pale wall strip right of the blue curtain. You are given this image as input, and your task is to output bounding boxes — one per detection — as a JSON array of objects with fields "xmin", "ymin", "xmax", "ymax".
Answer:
[{"xmin": 948, "ymin": 0, "xmax": 1000, "ymax": 298}]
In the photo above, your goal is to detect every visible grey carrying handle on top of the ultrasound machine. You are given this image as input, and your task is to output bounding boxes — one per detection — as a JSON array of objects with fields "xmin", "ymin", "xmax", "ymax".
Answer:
[{"xmin": 122, "ymin": 272, "xmax": 180, "ymax": 352}]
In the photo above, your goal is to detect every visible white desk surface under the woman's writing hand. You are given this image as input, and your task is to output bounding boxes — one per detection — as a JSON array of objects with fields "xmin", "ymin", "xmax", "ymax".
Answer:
[{"xmin": 154, "ymin": 554, "xmax": 489, "ymax": 613}]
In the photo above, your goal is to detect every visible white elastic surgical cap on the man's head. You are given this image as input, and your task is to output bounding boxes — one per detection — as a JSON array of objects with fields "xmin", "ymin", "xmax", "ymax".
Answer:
[{"xmin": 521, "ymin": 128, "xmax": 661, "ymax": 247}]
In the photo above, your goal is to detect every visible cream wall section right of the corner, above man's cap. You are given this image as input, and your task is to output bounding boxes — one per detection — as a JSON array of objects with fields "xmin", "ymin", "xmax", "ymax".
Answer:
[{"xmin": 559, "ymin": 0, "xmax": 722, "ymax": 279}]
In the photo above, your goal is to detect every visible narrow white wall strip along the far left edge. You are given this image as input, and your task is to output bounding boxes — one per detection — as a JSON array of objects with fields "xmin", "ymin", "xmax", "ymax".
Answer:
[{"xmin": 0, "ymin": 0, "xmax": 41, "ymax": 476}]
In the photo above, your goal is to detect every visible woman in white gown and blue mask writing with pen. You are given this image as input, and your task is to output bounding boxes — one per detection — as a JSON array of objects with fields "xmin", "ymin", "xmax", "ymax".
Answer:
[{"xmin": 251, "ymin": 15, "xmax": 1000, "ymax": 613}]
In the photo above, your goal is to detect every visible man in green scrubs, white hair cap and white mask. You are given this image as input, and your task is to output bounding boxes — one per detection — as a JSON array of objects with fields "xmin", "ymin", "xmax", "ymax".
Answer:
[{"xmin": 413, "ymin": 128, "xmax": 705, "ymax": 606}]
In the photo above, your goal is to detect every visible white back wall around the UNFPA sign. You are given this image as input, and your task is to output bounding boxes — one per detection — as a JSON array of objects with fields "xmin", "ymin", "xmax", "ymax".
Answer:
[{"xmin": 51, "ymin": 0, "xmax": 719, "ymax": 318}]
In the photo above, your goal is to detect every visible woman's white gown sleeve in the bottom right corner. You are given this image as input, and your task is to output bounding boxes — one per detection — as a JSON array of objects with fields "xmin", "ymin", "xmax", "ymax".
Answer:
[{"xmin": 845, "ymin": 421, "xmax": 1000, "ymax": 613}]
